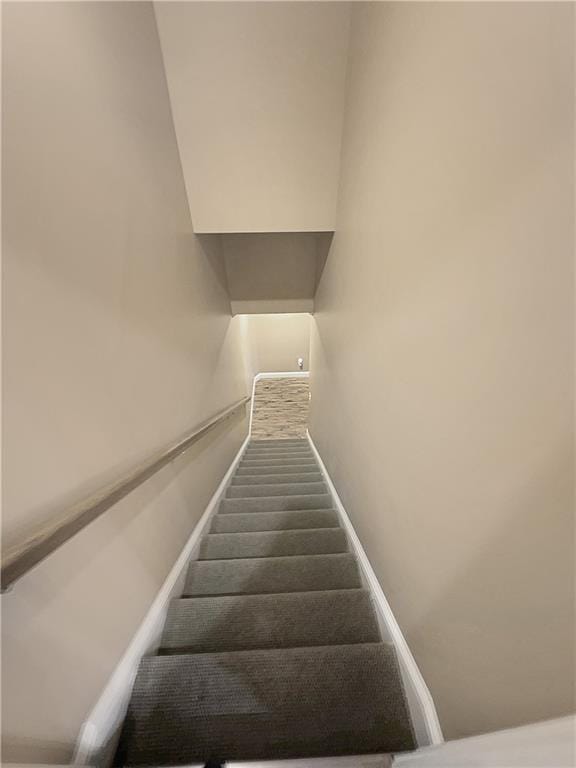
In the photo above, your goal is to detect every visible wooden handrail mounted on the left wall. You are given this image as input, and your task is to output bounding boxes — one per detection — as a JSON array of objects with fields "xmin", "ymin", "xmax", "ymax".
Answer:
[{"xmin": 1, "ymin": 397, "xmax": 252, "ymax": 592}]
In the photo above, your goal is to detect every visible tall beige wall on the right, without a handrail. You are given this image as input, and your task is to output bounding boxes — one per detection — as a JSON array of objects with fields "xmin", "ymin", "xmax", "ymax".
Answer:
[{"xmin": 311, "ymin": 3, "xmax": 574, "ymax": 738}]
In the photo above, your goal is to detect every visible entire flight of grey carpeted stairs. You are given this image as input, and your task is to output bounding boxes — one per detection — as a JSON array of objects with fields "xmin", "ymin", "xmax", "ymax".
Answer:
[{"xmin": 116, "ymin": 440, "xmax": 415, "ymax": 766}]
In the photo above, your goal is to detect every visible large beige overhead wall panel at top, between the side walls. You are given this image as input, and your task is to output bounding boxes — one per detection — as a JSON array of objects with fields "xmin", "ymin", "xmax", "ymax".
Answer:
[{"xmin": 155, "ymin": 2, "xmax": 349, "ymax": 232}]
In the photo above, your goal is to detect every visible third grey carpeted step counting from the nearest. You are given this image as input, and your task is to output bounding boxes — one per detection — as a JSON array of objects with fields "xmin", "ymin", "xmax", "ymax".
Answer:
[{"xmin": 184, "ymin": 552, "xmax": 362, "ymax": 596}]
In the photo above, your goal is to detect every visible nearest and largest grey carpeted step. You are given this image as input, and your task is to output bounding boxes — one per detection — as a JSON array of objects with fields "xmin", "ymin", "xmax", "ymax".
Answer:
[{"xmin": 119, "ymin": 643, "xmax": 414, "ymax": 766}]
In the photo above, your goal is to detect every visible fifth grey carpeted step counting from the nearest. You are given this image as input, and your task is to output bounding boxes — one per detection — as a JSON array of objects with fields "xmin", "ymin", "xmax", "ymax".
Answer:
[{"xmin": 210, "ymin": 509, "xmax": 340, "ymax": 533}]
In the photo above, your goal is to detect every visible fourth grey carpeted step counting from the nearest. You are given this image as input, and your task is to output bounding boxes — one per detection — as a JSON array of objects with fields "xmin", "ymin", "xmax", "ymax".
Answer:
[{"xmin": 199, "ymin": 528, "xmax": 348, "ymax": 560}]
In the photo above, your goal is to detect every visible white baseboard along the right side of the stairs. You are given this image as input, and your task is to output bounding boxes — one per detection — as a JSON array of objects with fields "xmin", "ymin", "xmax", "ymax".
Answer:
[{"xmin": 307, "ymin": 433, "xmax": 444, "ymax": 747}]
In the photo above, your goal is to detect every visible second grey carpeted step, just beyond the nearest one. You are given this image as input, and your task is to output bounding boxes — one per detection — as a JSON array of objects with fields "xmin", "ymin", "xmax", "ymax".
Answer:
[{"xmin": 160, "ymin": 589, "xmax": 380, "ymax": 653}]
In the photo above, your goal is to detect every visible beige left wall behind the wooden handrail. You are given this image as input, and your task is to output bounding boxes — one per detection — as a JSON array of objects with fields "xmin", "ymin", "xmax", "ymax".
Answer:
[{"xmin": 2, "ymin": 3, "xmax": 246, "ymax": 762}]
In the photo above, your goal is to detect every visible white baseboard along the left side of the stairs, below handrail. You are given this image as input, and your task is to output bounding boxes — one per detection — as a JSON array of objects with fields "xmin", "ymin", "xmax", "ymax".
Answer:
[{"xmin": 72, "ymin": 434, "xmax": 250, "ymax": 766}]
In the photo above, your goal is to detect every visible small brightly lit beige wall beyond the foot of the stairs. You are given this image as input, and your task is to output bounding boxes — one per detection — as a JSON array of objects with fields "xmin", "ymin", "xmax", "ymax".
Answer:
[{"xmin": 240, "ymin": 313, "xmax": 312, "ymax": 376}]
